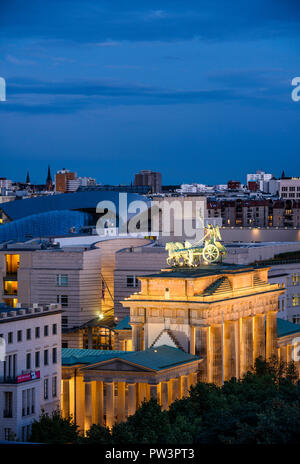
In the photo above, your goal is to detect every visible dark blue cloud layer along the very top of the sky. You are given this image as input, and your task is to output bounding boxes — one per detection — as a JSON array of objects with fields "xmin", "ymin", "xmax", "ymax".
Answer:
[{"xmin": 0, "ymin": 0, "xmax": 300, "ymax": 47}]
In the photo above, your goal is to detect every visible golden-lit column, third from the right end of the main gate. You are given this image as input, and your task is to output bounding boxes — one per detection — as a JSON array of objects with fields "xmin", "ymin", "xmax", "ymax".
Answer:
[{"xmin": 240, "ymin": 317, "xmax": 253, "ymax": 377}]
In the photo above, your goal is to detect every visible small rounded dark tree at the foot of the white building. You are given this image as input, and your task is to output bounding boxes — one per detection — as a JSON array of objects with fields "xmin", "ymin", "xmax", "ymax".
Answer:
[{"xmin": 29, "ymin": 411, "xmax": 79, "ymax": 444}]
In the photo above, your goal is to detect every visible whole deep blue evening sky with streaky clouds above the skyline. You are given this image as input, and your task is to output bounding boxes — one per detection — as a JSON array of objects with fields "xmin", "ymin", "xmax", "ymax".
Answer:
[{"xmin": 0, "ymin": 0, "xmax": 300, "ymax": 184}]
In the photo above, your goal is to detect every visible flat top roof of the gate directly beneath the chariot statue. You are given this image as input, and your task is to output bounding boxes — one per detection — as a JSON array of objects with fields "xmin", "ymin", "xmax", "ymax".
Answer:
[{"xmin": 144, "ymin": 263, "xmax": 266, "ymax": 279}]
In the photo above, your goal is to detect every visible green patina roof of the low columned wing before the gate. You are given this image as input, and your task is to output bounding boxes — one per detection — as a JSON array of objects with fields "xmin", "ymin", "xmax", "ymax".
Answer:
[{"xmin": 62, "ymin": 345, "xmax": 200, "ymax": 371}]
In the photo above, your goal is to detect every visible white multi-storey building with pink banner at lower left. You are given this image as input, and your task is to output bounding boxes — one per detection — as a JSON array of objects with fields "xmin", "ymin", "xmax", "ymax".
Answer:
[{"xmin": 0, "ymin": 305, "xmax": 62, "ymax": 441}]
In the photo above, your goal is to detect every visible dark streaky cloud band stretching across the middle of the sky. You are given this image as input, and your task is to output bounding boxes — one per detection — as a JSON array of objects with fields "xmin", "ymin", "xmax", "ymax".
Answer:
[{"xmin": 0, "ymin": 73, "xmax": 290, "ymax": 114}]
